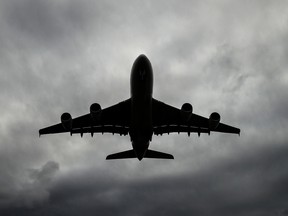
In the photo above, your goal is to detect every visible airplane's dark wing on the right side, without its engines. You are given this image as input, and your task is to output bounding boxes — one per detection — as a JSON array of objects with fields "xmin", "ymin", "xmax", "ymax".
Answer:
[{"xmin": 152, "ymin": 99, "xmax": 240, "ymax": 135}]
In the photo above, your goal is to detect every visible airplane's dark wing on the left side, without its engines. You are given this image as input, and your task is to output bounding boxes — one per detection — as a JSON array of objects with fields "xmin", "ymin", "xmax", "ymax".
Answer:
[{"xmin": 39, "ymin": 99, "xmax": 131, "ymax": 136}]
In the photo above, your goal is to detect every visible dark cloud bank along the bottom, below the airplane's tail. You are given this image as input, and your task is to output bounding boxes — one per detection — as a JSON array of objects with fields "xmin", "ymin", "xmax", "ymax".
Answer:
[{"xmin": 2, "ymin": 141, "xmax": 288, "ymax": 215}]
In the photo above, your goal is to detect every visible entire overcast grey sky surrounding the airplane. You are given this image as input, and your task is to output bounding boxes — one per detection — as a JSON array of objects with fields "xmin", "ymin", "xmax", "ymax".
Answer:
[{"xmin": 0, "ymin": 0, "xmax": 288, "ymax": 216}]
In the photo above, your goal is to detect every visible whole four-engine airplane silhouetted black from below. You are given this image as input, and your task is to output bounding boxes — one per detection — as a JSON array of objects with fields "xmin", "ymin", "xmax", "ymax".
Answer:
[{"xmin": 39, "ymin": 54, "xmax": 240, "ymax": 161}]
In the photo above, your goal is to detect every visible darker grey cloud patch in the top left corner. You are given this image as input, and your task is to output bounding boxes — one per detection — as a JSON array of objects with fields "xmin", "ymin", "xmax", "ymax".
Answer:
[{"xmin": 1, "ymin": 0, "xmax": 101, "ymax": 49}]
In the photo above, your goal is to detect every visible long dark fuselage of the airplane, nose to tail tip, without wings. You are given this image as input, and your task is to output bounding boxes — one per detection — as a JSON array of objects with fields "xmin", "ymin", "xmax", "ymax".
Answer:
[{"xmin": 129, "ymin": 55, "xmax": 153, "ymax": 160}]
